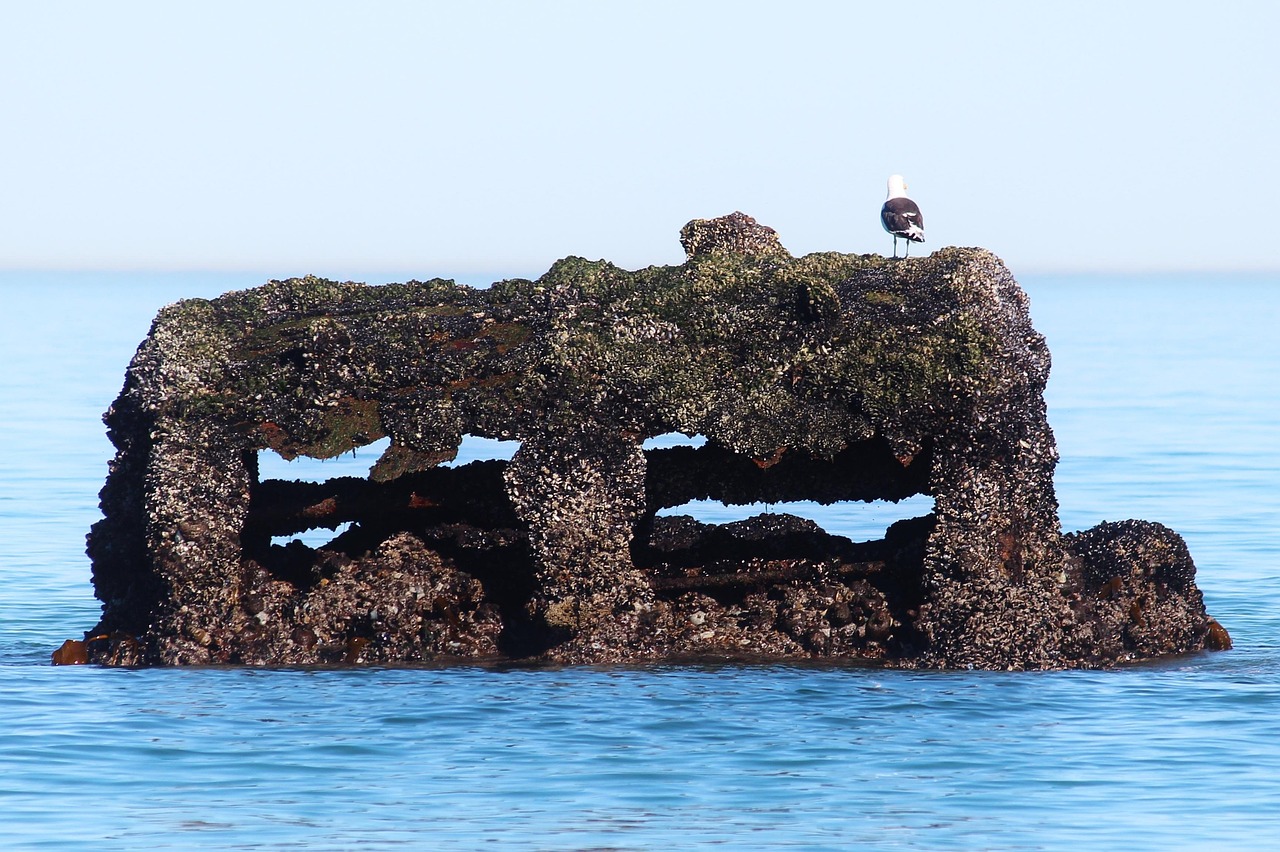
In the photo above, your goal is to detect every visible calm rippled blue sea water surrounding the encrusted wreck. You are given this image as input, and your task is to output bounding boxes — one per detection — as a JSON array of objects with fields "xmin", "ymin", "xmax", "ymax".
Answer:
[{"xmin": 0, "ymin": 272, "xmax": 1280, "ymax": 849}]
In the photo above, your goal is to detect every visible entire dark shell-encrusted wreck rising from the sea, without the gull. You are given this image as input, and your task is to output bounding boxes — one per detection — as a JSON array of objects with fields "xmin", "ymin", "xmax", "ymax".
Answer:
[{"xmin": 72, "ymin": 214, "xmax": 1230, "ymax": 669}]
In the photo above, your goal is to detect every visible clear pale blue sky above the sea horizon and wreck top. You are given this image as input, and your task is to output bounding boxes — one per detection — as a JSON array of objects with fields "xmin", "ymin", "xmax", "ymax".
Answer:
[{"xmin": 0, "ymin": 0, "xmax": 1280, "ymax": 278}]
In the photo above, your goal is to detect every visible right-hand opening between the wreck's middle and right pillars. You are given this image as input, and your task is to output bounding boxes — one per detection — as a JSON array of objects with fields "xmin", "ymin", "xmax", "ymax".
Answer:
[{"xmin": 632, "ymin": 436, "xmax": 933, "ymax": 610}]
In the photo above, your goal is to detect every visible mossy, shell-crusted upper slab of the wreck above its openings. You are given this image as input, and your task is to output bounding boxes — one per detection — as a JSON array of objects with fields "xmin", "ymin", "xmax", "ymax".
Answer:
[{"xmin": 135, "ymin": 214, "xmax": 1024, "ymax": 469}]
